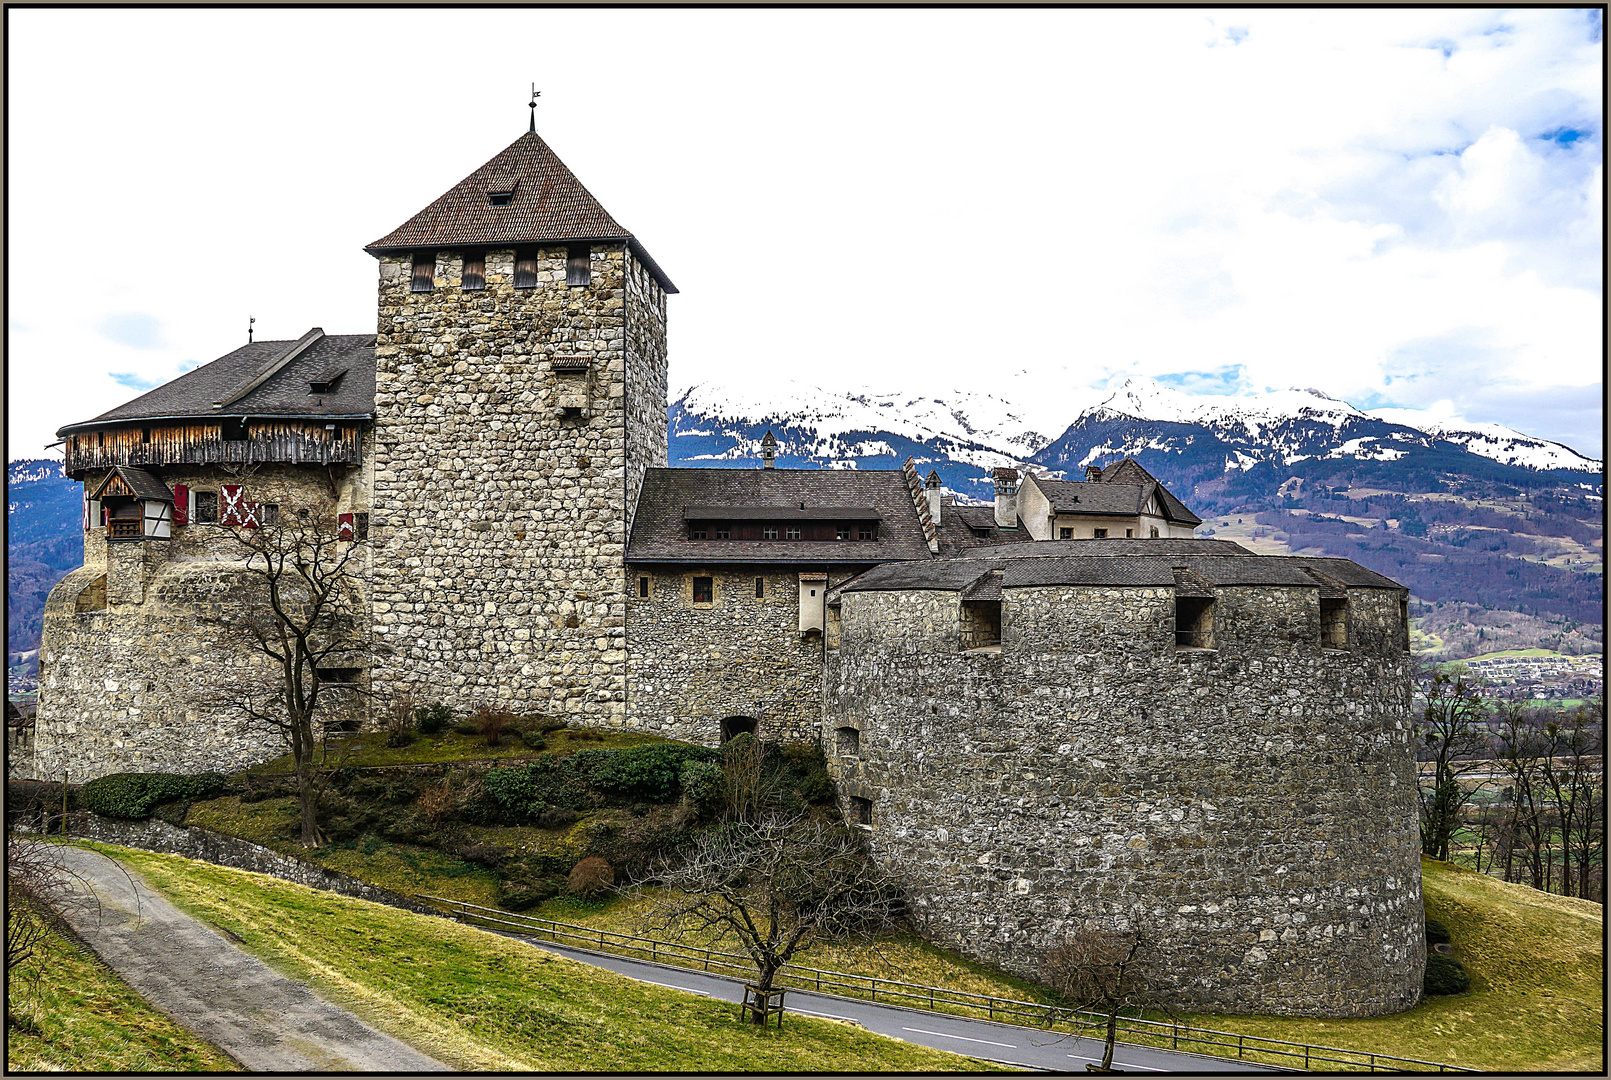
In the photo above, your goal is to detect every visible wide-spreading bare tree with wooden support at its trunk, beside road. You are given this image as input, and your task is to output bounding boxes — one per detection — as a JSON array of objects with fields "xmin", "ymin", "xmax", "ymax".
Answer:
[{"xmin": 638, "ymin": 817, "xmax": 899, "ymax": 1024}]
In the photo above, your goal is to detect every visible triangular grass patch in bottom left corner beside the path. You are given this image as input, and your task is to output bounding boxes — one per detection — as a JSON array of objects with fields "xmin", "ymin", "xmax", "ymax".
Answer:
[{"xmin": 6, "ymin": 915, "xmax": 240, "ymax": 1072}]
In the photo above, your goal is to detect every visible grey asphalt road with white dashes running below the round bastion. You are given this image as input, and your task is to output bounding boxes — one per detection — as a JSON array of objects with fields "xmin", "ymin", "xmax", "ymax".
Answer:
[{"xmin": 506, "ymin": 933, "xmax": 1284, "ymax": 1072}]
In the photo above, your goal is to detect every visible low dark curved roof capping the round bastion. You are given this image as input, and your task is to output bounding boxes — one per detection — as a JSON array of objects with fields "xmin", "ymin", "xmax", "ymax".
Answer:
[{"xmin": 841, "ymin": 538, "xmax": 1403, "ymax": 592}]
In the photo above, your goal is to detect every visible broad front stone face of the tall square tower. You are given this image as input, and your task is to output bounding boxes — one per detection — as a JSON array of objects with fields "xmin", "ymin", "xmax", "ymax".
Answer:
[{"xmin": 372, "ymin": 245, "xmax": 637, "ymax": 725}]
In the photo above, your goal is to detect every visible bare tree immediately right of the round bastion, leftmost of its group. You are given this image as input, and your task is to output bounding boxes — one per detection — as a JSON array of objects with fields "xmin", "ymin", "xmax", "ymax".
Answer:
[{"xmin": 1416, "ymin": 667, "xmax": 1489, "ymax": 862}]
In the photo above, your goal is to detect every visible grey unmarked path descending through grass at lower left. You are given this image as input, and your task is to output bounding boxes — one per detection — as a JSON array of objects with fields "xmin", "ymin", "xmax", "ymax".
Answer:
[{"xmin": 46, "ymin": 848, "xmax": 451, "ymax": 1072}]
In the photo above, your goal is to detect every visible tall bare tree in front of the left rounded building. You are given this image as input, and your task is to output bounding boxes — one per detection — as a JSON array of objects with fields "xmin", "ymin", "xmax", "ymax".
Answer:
[{"xmin": 209, "ymin": 503, "xmax": 367, "ymax": 848}]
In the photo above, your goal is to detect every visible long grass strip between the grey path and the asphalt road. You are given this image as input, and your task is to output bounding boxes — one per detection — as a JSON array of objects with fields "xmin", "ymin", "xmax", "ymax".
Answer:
[{"xmin": 81, "ymin": 845, "xmax": 996, "ymax": 1072}]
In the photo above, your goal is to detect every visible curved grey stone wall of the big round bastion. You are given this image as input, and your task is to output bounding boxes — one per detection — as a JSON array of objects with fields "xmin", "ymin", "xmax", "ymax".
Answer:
[{"xmin": 823, "ymin": 587, "xmax": 1426, "ymax": 1016}]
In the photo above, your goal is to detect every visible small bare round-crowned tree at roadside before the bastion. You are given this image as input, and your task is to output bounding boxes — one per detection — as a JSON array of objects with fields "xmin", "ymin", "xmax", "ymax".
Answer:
[{"xmin": 1041, "ymin": 920, "xmax": 1163, "ymax": 1072}]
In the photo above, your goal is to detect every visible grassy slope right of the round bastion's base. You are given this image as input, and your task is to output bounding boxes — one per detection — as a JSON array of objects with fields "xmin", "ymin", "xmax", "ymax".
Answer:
[{"xmin": 1194, "ymin": 859, "xmax": 1605, "ymax": 1072}]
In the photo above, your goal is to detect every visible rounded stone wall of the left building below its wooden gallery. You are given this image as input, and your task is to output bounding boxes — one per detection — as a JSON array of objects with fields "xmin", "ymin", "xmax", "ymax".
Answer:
[{"xmin": 31, "ymin": 464, "xmax": 369, "ymax": 782}]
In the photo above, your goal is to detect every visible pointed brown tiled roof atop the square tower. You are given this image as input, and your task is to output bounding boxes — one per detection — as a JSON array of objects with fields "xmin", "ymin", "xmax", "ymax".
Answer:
[{"xmin": 364, "ymin": 131, "xmax": 677, "ymax": 292}]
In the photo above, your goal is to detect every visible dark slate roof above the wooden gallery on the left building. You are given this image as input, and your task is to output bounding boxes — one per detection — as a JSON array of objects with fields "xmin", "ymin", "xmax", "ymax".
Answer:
[{"xmin": 56, "ymin": 334, "xmax": 375, "ymax": 437}]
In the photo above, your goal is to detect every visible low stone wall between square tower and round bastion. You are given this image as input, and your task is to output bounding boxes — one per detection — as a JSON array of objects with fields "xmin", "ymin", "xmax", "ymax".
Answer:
[{"xmin": 627, "ymin": 566, "xmax": 849, "ymax": 746}]
